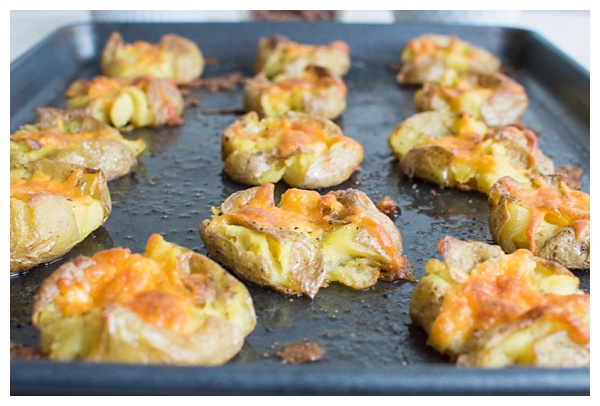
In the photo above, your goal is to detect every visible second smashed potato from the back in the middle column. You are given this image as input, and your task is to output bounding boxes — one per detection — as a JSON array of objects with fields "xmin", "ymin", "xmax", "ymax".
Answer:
[{"xmin": 244, "ymin": 66, "xmax": 348, "ymax": 120}]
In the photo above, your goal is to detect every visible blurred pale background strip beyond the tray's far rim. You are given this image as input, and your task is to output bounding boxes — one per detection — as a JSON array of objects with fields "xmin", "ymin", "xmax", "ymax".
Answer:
[{"xmin": 10, "ymin": 10, "xmax": 590, "ymax": 70}]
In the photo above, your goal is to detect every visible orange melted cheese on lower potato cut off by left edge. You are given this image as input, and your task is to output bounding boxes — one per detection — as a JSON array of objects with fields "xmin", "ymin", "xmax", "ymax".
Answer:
[{"xmin": 10, "ymin": 168, "xmax": 98, "ymax": 202}]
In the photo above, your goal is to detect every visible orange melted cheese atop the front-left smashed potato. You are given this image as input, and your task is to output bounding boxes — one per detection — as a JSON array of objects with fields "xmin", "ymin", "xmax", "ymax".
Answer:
[{"xmin": 55, "ymin": 236, "xmax": 197, "ymax": 333}]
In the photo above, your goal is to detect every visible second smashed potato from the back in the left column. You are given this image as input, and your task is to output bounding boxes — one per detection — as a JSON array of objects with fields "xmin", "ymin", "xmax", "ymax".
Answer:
[{"xmin": 65, "ymin": 76, "xmax": 184, "ymax": 128}]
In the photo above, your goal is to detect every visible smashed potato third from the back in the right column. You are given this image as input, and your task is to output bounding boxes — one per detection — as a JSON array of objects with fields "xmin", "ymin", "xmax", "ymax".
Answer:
[{"xmin": 388, "ymin": 112, "xmax": 554, "ymax": 193}]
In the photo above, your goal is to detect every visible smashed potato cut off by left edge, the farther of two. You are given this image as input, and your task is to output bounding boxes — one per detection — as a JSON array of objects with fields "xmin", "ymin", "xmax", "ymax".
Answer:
[{"xmin": 10, "ymin": 108, "xmax": 146, "ymax": 181}]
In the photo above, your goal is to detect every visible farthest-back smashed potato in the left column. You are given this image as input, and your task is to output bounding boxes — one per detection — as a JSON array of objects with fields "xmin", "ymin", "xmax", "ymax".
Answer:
[{"xmin": 100, "ymin": 32, "xmax": 204, "ymax": 84}]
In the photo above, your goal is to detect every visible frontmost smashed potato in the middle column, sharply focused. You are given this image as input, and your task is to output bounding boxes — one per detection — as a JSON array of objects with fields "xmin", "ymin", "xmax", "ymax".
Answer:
[{"xmin": 200, "ymin": 184, "xmax": 413, "ymax": 298}]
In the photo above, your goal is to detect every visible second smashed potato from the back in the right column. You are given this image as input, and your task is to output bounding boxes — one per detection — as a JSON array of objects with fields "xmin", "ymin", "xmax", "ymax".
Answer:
[{"xmin": 415, "ymin": 69, "xmax": 529, "ymax": 127}]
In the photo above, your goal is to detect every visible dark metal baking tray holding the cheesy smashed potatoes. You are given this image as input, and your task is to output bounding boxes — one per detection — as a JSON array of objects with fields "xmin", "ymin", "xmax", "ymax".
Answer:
[{"xmin": 10, "ymin": 23, "xmax": 590, "ymax": 395}]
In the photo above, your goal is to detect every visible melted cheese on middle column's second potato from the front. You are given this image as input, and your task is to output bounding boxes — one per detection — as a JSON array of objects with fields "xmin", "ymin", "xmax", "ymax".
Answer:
[{"xmin": 233, "ymin": 118, "xmax": 354, "ymax": 158}]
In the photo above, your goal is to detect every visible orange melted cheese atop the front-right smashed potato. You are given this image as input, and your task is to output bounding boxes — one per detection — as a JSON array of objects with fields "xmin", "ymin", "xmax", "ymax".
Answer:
[{"xmin": 429, "ymin": 250, "xmax": 590, "ymax": 348}]
